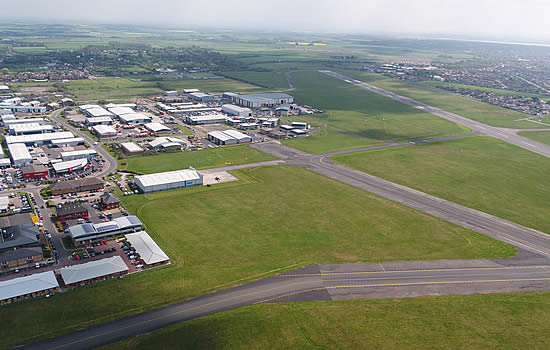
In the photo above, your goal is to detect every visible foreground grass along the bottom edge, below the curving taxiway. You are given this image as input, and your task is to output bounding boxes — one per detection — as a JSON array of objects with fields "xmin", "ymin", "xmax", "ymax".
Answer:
[{"xmin": 102, "ymin": 293, "xmax": 550, "ymax": 350}]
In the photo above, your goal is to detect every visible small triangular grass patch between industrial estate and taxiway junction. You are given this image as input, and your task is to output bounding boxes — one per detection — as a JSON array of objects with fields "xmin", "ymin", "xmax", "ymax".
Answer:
[{"xmin": 281, "ymin": 125, "xmax": 382, "ymax": 154}]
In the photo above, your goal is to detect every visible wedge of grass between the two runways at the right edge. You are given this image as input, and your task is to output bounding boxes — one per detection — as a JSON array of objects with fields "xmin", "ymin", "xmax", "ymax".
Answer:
[{"xmin": 333, "ymin": 137, "xmax": 550, "ymax": 233}]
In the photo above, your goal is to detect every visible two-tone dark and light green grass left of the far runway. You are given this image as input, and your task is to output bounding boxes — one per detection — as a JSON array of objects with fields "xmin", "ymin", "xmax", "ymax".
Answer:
[{"xmin": 292, "ymin": 71, "xmax": 469, "ymax": 142}]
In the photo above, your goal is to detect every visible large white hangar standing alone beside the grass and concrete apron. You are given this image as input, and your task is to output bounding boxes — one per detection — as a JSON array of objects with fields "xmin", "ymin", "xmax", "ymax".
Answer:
[{"xmin": 134, "ymin": 168, "xmax": 203, "ymax": 193}]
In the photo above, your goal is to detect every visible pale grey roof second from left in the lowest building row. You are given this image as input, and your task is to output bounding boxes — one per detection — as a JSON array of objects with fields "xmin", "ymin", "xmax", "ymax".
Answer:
[{"xmin": 60, "ymin": 255, "xmax": 128, "ymax": 284}]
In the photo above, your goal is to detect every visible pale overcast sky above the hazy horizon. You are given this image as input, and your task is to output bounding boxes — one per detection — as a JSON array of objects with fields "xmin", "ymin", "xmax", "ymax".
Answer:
[{"xmin": 4, "ymin": 0, "xmax": 550, "ymax": 43}]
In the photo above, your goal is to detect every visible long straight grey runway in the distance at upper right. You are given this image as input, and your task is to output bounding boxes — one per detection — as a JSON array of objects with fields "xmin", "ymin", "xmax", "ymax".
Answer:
[{"xmin": 320, "ymin": 70, "xmax": 550, "ymax": 157}]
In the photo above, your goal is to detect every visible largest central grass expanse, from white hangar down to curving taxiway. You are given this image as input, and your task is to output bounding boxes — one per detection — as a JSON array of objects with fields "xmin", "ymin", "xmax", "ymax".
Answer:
[{"xmin": 0, "ymin": 166, "xmax": 516, "ymax": 347}]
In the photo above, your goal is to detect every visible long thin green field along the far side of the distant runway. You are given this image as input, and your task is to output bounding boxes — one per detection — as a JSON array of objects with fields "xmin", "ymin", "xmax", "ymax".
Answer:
[{"xmin": 337, "ymin": 70, "xmax": 543, "ymax": 129}]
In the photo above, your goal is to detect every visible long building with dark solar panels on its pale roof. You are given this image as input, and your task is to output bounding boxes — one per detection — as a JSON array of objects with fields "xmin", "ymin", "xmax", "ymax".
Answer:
[{"xmin": 69, "ymin": 215, "xmax": 142, "ymax": 244}]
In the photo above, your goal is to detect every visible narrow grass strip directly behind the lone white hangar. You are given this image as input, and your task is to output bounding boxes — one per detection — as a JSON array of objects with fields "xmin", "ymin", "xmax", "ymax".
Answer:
[{"xmin": 121, "ymin": 145, "xmax": 276, "ymax": 174}]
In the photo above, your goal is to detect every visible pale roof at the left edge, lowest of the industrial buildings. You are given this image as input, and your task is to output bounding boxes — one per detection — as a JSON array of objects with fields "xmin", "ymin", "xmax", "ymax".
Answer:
[{"xmin": 0, "ymin": 271, "xmax": 59, "ymax": 300}]
